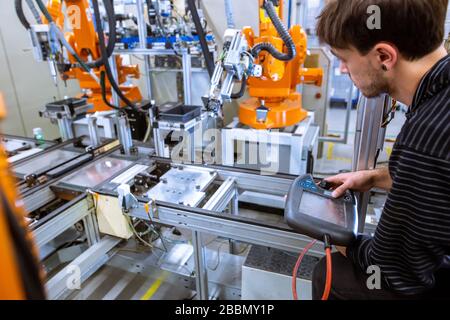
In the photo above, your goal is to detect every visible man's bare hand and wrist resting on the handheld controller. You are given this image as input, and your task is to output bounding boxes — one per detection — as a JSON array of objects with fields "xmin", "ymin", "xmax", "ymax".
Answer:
[{"xmin": 325, "ymin": 168, "xmax": 392, "ymax": 198}]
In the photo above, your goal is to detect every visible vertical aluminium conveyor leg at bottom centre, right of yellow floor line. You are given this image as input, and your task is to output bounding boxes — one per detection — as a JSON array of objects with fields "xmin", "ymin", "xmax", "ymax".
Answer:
[{"xmin": 192, "ymin": 230, "xmax": 208, "ymax": 300}]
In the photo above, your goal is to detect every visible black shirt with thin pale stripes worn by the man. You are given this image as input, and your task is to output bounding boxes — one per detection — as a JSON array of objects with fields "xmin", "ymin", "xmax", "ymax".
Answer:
[{"xmin": 347, "ymin": 56, "xmax": 450, "ymax": 295}]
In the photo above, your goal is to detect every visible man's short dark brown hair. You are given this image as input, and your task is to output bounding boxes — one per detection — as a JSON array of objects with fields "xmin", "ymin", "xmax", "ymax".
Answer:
[{"xmin": 317, "ymin": 0, "xmax": 448, "ymax": 60}]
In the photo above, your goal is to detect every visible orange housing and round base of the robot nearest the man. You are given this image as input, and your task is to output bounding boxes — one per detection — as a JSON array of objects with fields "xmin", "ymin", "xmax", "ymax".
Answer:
[{"xmin": 239, "ymin": 0, "xmax": 323, "ymax": 129}]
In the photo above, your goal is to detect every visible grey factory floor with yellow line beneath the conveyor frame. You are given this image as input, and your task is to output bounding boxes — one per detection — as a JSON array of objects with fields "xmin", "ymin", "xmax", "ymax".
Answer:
[{"xmin": 66, "ymin": 230, "xmax": 250, "ymax": 300}]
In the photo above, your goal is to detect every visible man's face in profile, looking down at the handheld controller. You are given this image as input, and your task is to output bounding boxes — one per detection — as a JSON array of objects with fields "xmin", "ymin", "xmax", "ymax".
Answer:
[{"xmin": 331, "ymin": 48, "xmax": 389, "ymax": 98}]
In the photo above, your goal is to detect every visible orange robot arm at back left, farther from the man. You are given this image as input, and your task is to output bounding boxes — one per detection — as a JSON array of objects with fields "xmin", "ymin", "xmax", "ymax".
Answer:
[{"xmin": 43, "ymin": 0, "xmax": 142, "ymax": 112}]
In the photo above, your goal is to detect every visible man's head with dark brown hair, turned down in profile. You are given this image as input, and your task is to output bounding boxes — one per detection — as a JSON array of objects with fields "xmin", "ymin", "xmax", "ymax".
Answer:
[{"xmin": 317, "ymin": 0, "xmax": 448, "ymax": 97}]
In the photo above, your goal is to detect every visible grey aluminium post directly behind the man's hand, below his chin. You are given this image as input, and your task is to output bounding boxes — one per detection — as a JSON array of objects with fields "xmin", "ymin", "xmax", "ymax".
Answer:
[{"xmin": 352, "ymin": 95, "xmax": 389, "ymax": 232}]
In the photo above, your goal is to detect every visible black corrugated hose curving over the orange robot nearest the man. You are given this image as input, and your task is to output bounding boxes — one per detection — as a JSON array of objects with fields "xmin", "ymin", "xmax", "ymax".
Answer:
[{"xmin": 252, "ymin": 0, "xmax": 296, "ymax": 61}]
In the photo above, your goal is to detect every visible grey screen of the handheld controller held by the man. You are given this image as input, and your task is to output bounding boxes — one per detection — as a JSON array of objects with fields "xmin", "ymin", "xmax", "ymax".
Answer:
[{"xmin": 299, "ymin": 192, "xmax": 347, "ymax": 228}]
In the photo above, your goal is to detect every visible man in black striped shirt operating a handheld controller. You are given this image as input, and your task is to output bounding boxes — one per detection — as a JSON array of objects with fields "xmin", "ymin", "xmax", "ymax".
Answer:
[{"xmin": 313, "ymin": 0, "xmax": 450, "ymax": 299}]
